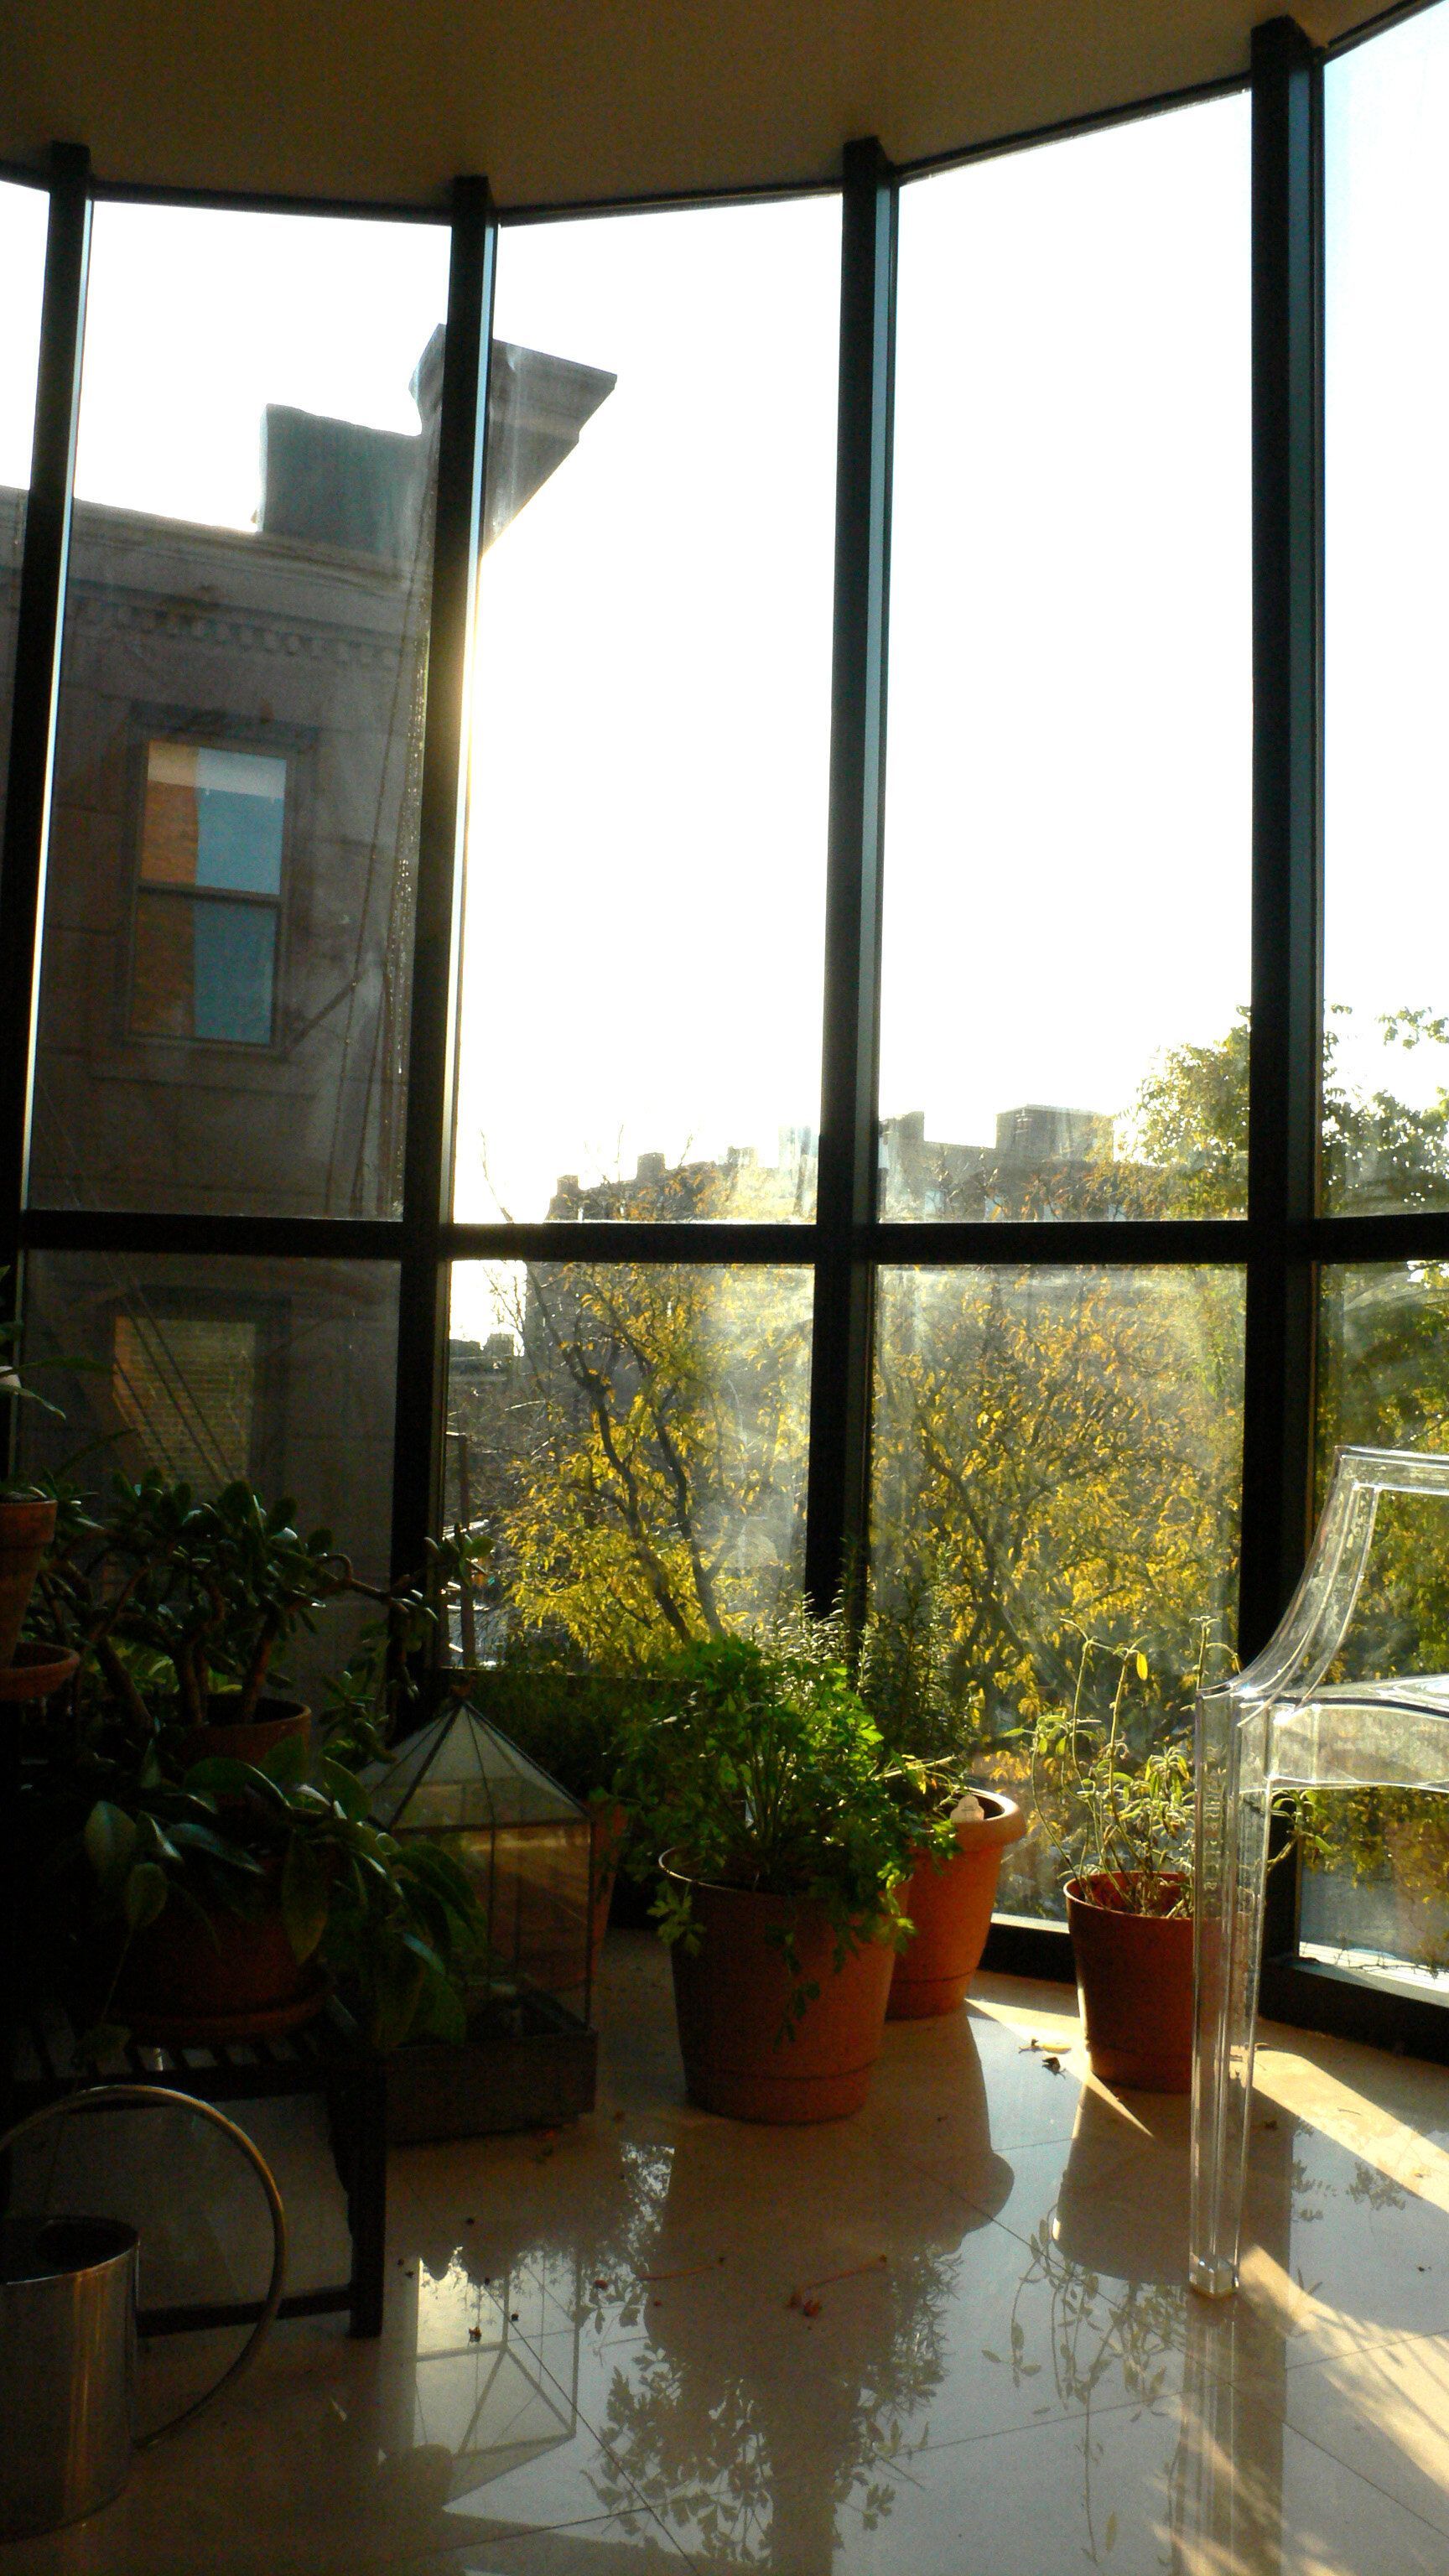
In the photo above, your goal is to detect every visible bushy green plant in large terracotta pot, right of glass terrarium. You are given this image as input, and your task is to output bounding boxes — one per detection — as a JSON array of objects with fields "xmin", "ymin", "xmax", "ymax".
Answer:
[{"xmin": 610, "ymin": 1636, "xmax": 916, "ymax": 2122}]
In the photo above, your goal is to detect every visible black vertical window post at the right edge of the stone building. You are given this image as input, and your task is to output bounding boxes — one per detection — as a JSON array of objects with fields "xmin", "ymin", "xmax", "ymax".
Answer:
[{"xmin": 392, "ymin": 178, "xmax": 497, "ymax": 1574}]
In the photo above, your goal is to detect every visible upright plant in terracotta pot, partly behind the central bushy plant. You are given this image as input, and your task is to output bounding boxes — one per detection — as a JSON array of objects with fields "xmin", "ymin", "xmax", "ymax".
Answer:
[{"xmin": 859, "ymin": 1587, "xmax": 1026, "ymax": 2023}]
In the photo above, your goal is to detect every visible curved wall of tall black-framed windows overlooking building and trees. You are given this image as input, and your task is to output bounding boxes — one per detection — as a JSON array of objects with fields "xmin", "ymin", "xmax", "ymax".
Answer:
[{"xmin": 11, "ymin": 30, "xmax": 1449, "ymax": 2055}]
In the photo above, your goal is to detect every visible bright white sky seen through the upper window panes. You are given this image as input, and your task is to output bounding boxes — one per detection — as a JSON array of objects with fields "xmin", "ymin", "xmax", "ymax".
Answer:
[{"xmin": 0, "ymin": 8, "xmax": 1449, "ymax": 1318}]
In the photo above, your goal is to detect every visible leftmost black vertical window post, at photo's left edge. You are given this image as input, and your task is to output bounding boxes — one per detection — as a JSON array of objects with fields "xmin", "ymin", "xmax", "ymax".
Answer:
[{"xmin": 0, "ymin": 144, "xmax": 91, "ymax": 1298}]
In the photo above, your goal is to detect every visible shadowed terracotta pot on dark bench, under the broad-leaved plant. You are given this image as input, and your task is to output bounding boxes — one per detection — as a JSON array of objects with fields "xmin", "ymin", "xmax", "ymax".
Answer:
[{"xmin": 111, "ymin": 1862, "xmax": 327, "ymax": 2038}]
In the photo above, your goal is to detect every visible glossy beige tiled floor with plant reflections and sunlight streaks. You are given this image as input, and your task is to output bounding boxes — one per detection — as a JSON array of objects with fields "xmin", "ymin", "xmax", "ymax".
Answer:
[{"xmin": 0, "ymin": 1935, "xmax": 1449, "ymax": 2576}]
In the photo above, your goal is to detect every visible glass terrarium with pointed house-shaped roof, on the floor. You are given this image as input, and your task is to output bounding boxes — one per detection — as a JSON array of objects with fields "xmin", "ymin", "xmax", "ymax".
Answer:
[{"xmin": 366, "ymin": 1703, "xmax": 593, "ymax": 2028}]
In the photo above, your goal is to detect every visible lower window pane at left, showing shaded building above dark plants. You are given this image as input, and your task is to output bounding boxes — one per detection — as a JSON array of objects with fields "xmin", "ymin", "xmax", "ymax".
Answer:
[{"xmin": 21, "ymin": 1252, "xmax": 397, "ymax": 1690}]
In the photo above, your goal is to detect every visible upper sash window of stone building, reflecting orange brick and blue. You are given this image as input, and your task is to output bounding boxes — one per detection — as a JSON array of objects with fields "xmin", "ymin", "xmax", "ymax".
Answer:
[{"xmin": 132, "ymin": 742, "xmax": 286, "ymax": 1046}]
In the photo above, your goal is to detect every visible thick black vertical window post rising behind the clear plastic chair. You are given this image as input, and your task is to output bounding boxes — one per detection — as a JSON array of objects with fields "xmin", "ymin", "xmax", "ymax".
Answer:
[{"xmin": 1238, "ymin": 18, "xmax": 1322, "ymax": 1690}]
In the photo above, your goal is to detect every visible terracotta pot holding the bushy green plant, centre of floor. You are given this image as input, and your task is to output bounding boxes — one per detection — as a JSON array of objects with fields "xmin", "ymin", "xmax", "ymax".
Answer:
[{"xmin": 662, "ymin": 1852, "xmax": 895, "ymax": 2122}]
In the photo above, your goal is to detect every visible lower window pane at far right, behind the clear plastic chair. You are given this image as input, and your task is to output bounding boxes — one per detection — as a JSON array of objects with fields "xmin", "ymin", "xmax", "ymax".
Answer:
[{"xmin": 1300, "ymin": 1262, "xmax": 1449, "ymax": 1983}]
